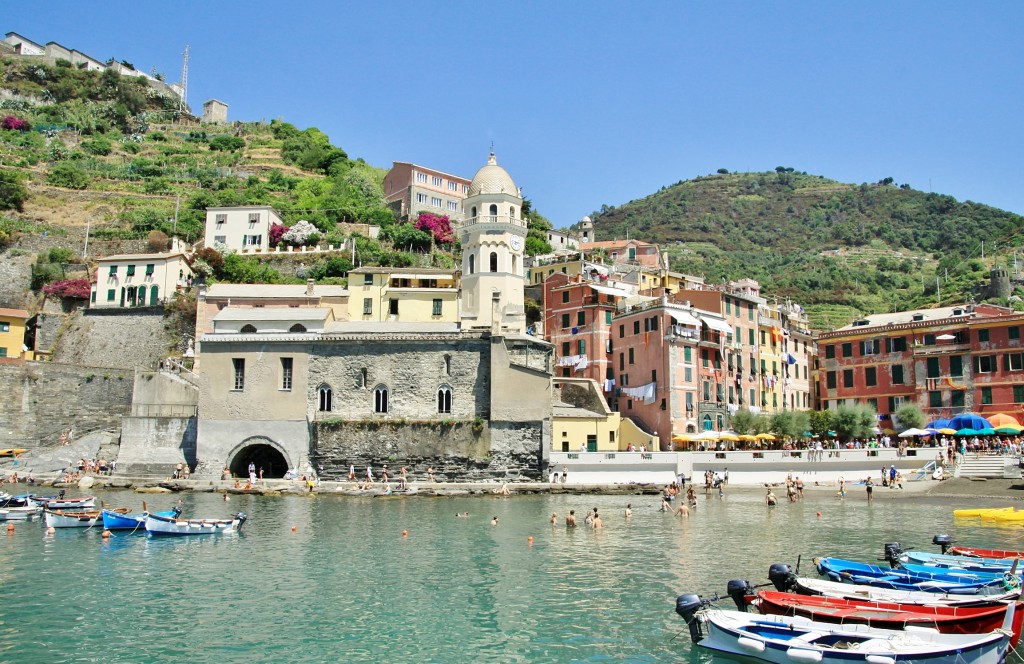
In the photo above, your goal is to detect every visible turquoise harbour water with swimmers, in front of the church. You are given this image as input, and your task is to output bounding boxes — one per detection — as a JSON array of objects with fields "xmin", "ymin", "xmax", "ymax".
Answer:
[{"xmin": 0, "ymin": 490, "xmax": 1024, "ymax": 663}]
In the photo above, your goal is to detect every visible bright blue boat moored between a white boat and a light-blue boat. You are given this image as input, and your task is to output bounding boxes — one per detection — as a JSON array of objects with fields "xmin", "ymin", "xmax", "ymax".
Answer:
[{"xmin": 815, "ymin": 557, "xmax": 1020, "ymax": 594}]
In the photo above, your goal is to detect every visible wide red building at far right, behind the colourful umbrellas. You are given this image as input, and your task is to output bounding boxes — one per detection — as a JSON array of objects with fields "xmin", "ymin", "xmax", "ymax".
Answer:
[{"xmin": 817, "ymin": 304, "xmax": 1024, "ymax": 427}]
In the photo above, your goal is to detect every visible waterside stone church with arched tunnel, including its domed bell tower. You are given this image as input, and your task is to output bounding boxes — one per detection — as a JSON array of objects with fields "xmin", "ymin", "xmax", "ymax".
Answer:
[{"xmin": 196, "ymin": 154, "xmax": 552, "ymax": 481}]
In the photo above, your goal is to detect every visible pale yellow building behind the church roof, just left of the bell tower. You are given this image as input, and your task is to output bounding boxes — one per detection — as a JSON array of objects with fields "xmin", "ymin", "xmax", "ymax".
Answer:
[{"xmin": 348, "ymin": 267, "xmax": 459, "ymax": 323}]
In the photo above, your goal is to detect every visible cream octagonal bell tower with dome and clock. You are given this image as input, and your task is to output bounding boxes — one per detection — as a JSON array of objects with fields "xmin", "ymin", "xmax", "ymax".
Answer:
[{"xmin": 459, "ymin": 152, "xmax": 526, "ymax": 334}]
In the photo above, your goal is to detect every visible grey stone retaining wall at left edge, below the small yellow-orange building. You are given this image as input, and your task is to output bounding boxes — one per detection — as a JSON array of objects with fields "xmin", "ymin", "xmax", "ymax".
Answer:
[{"xmin": 0, "ymin": 362, "xmax": 132, "ymax": 449}]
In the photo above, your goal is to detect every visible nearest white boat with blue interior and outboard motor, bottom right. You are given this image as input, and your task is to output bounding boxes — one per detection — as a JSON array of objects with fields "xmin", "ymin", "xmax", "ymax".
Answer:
[{"xmin": 676, "ymin": 606, "xmax": 1010, "ymax": 664}]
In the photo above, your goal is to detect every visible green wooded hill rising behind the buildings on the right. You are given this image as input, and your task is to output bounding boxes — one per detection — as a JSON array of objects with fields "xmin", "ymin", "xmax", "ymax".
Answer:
[{"xmin": 592, "ymin": 168, "xmax": 1024, "ymax": 329}]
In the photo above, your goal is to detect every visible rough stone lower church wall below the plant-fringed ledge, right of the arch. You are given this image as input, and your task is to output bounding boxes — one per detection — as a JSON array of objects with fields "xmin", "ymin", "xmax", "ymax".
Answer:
[{"xmin": 310, "ymin": 422, "xmax": 541, "ymax": 482}]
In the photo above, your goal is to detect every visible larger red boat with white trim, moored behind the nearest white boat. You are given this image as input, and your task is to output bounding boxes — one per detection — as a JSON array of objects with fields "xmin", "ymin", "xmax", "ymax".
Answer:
[{"xmin": 751, "ymin": 590, "xmax": 1024, "ymax": 647}]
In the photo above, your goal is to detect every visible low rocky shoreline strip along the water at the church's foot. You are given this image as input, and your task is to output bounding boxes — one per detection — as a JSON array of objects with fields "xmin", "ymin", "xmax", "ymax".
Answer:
[{"xmin": 36, "ymin": 476, "xmax": 663, "ymax": 498}]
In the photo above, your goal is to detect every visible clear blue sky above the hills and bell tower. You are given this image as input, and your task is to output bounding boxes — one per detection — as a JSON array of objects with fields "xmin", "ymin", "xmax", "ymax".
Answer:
[{"xmin": 0, "ymin": 0, "xmax": 1024, "ymax": 226}]
